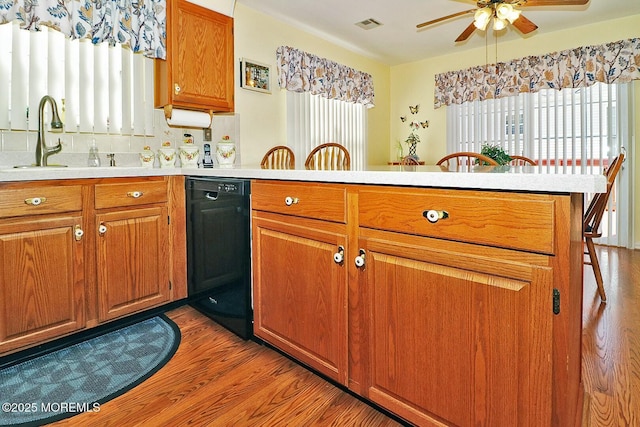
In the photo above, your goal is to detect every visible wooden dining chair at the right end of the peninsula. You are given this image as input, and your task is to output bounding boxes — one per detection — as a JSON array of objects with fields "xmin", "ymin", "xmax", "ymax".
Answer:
[{"xmin": 582, "ymin": 153, "xmax": 624, "ymax": 302}]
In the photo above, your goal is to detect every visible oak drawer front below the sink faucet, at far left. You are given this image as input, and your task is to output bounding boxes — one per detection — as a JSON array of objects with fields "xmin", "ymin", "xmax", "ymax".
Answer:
[{"xmin": 0, "ymin": 185, "xmax": 82, "ymax": 218}]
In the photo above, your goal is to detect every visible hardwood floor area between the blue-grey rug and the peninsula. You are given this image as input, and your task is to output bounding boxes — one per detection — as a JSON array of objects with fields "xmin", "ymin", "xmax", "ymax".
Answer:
[{"xmin": 53, "ymin": 306, "xmax": 401, "ymax": 427}]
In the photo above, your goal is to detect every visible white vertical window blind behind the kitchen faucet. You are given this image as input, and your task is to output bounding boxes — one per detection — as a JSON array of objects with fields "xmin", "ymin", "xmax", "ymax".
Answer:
[{"xmin": 0, "ymin": 21, "xmax": 153, "ymax": 135}]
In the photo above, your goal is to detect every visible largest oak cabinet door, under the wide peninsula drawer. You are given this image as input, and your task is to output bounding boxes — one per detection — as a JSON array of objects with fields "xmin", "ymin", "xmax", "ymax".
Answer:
[{"xmin": 360, "ymin": 231, "xmax": 552, "ymax": 426}]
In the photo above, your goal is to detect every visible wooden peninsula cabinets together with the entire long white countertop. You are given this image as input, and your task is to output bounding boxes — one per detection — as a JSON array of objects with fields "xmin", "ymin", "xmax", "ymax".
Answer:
[{"xmin": 0, "ymin": 166, "xmax": 605, "ymax": 426}]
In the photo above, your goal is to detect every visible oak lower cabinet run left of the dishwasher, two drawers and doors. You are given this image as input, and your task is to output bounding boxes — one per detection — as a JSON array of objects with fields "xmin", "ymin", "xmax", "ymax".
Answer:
[{"xmin": 0, "ymin": 176, "xmax": 186, "ymax": 357}]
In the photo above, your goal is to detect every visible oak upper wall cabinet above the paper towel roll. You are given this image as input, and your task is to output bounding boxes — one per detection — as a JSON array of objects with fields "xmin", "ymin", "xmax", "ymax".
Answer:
[{"xmin": 155, "ymin": 0, "xmax": 234, "ymax": 112}]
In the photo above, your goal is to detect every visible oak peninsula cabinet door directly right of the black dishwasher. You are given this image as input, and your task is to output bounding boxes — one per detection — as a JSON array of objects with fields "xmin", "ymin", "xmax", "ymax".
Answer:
[{"xmin": 253, "ymin": 212, "xmax": 348, "ymax": 384}]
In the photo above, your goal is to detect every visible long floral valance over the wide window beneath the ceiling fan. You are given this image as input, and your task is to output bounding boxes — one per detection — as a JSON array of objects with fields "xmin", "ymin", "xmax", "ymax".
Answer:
[{"xmin": 435, "ymin": 38, "xmax": 640, "ymax": 108}]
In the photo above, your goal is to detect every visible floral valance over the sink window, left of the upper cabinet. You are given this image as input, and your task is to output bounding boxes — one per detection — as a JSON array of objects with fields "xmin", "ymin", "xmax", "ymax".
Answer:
[{"xmin": 0, "ymin": 0, "xmax": 167, "ymax": 59}]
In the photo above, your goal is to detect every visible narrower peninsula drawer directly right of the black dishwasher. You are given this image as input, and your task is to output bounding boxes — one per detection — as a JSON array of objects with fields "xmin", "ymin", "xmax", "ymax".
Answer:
[{"xmin": 251, "ymin": 181, "xmax": 347, "ymax": 223}]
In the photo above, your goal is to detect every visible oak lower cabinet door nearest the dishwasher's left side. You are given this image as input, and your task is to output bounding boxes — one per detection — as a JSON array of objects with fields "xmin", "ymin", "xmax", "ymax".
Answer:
[{"xmin": 96, "ymin": 207, "xmax": 170, "ymax": 321}]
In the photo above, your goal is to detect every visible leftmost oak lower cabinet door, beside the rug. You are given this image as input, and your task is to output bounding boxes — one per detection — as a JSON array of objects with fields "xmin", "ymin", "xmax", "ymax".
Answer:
[{"xmin": 0, "ymin": 215, "xmax": 85, "ymax": 355}]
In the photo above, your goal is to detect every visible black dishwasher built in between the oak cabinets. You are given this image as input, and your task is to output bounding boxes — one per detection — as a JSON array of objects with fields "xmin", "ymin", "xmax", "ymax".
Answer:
[{"xmin": 186, "ymin": 177, "xmax": 253, "ymax": 339}]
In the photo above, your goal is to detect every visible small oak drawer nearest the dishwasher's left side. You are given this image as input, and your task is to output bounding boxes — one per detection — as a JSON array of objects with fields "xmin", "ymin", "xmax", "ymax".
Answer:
[{"xmin": 95, "ymin": 181, "xmax": 167, "ymax": 209}]
